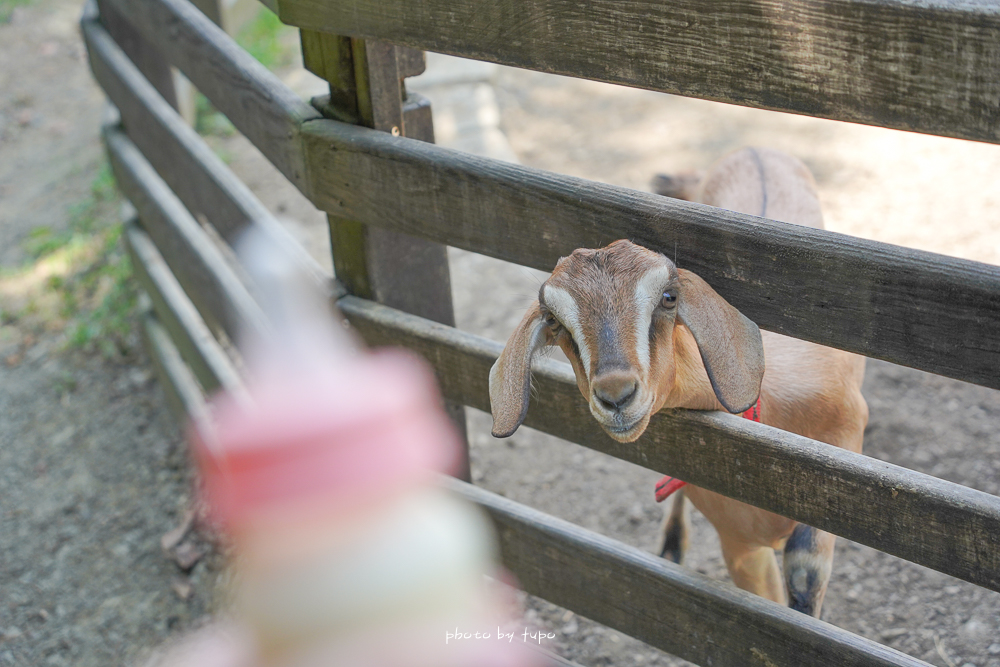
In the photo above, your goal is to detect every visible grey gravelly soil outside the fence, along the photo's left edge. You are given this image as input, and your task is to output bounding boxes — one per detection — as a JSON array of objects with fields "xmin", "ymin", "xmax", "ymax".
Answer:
[{"xmin": 0, "ymin": 0, "xmax": 221, "ymax": 667}]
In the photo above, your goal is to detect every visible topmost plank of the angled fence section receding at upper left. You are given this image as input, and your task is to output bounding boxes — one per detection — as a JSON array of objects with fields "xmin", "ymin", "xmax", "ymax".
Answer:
[{"xmin": 96, "ymin": 0, "xmax": 319, "ymax": 189}]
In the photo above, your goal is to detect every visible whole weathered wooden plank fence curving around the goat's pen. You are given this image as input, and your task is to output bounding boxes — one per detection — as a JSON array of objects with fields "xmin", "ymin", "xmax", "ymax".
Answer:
[{"xmin": 82, "ymin": 0, "xmax": 1000, "ymax": 667}]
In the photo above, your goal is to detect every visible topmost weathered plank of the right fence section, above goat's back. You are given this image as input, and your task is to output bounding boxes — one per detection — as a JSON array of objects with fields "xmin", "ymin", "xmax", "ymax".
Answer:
[{"xmin": 278, "ymin": 0, "xmax": 1000, "ymax": 143}]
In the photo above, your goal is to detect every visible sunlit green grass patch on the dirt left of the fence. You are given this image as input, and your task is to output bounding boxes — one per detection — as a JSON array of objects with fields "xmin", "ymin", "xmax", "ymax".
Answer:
[{"xmin": 0, "ymin": 165, "xmax": 137, "ymax": 358}]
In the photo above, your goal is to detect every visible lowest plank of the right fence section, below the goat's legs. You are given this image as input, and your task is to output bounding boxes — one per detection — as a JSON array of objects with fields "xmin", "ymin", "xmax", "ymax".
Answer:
[{"xmin": 444, "ymin": 480, "xmax": 927, "ymax": 667}]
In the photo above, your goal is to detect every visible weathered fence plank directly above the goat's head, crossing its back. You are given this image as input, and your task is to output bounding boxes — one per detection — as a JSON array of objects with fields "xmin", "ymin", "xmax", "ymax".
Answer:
[{"xmin": 303, "ymin": 120, "xmax": 1000, "ymax": 388}]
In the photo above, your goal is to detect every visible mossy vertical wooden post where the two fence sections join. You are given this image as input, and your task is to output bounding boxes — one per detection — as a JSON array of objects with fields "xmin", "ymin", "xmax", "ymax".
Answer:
[{"xmin": 302, "ymin": 30, "xmax": 470, "ymax": 481}]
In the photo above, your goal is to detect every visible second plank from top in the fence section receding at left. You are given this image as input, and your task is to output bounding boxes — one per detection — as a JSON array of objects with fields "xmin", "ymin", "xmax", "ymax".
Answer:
[{"xmin": 82, "ymin": 15, "xmax": 330, "ymax": 291}]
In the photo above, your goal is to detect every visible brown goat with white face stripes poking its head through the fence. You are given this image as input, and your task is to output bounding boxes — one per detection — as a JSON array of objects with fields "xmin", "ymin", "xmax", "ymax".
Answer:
[{"xmin": 490, "ymin": 148, "xmax": 868, "ymax": 617}]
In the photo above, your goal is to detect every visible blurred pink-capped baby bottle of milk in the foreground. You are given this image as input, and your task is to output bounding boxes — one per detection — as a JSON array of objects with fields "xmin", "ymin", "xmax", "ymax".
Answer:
[{"xmin": 194, "ymin": 230, "xmax": 533, "ymax": 667}]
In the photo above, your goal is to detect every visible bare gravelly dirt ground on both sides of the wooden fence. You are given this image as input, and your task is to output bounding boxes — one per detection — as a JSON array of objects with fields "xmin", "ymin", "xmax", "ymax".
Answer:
[{"xmin": 0, "ymin": 0, "xmax": 1000, "ymax": 667}]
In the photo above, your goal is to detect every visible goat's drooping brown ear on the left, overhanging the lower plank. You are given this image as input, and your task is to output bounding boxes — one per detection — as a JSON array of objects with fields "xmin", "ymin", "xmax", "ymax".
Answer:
[{"xmin": 490, "ymin": 301, "xmax": 549, "ymax": 438}]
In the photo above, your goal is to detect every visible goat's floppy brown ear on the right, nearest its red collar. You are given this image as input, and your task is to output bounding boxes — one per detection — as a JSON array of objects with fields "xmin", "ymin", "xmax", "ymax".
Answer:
[{"xmin": 677, "ymin": 269, "xmax": 764, "ymax": 413}]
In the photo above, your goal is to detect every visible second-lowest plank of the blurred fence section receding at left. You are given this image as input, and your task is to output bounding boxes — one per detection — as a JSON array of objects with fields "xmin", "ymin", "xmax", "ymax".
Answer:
[{"xmin": 124, "ymin": 220, "xmax": 243, "ymax": 393}]
